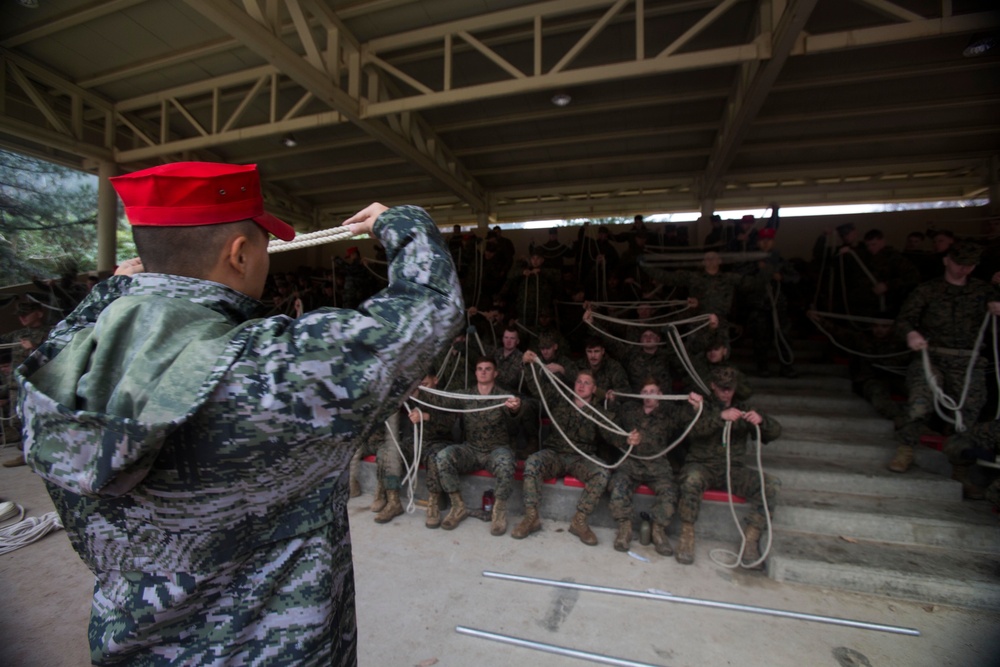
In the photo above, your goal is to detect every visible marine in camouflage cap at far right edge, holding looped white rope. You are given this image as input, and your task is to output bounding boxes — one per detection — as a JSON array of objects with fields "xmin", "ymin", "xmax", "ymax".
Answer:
[{"xmin": 889, "ymin": 243, "xmax": 1000, "ymax": 472}]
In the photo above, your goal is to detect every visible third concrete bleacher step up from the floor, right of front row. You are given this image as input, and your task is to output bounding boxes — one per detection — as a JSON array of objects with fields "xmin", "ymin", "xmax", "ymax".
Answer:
[{"xmin": 748, "ymin": 456, "xmax": 962, "ymax": 501}]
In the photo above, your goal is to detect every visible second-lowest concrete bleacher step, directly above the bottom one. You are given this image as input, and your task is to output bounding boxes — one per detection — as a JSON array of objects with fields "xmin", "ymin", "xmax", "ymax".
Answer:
[{"xmin": 774, "ymin": 489, "xmax": 1000, "ymax": 555}]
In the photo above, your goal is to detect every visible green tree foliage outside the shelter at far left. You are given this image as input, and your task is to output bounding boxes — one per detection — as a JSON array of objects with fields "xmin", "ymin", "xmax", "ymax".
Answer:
[{"xmin": 0, "ymin": 151, "xmax": 135, "ymax": 285}]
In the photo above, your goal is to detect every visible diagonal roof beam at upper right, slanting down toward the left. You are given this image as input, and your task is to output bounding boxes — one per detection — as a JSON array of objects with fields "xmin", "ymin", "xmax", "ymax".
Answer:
[{"xmin": 701, "ymin": 0, "xmax": 817, "ymax": 198}]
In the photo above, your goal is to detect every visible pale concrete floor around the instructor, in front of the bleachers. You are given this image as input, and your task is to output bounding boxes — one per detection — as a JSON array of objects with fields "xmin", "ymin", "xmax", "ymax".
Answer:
[{"xmin": 0, "ymin": 449, "xmax": 1000, "ymax": 667}]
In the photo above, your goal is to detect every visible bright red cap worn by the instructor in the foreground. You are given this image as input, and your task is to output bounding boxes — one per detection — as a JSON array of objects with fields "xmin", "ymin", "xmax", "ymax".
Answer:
[{"xmin": 110, "ymin": 162, "xmax": 295, "ymax": 241}]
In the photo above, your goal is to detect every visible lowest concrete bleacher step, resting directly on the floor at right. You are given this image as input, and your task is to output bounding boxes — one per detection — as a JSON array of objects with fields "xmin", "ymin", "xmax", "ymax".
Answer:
[{"xmin": 768, "ymin": 531, "xmax": 1000, "ymax": 611}]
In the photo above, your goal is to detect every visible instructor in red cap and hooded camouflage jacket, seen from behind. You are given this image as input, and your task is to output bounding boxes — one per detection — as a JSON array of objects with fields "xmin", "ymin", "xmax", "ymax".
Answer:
[{"xmin": 18, "ymin": 163, "xmax": 463, "ymax": 665}]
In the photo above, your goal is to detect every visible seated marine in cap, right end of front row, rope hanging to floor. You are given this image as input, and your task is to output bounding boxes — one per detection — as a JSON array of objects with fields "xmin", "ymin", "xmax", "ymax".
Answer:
[{"xmin": 677, "ymin": 366, "xmax": 781, "ymax": 563}]
